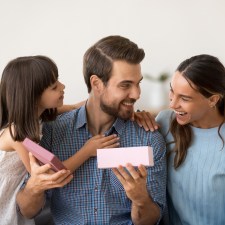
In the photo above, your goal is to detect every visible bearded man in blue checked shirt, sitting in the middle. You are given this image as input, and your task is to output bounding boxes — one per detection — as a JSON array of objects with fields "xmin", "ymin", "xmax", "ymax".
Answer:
[{"xmin": 17, "ymin": 36, "xmax": 166, "ymax": 225}]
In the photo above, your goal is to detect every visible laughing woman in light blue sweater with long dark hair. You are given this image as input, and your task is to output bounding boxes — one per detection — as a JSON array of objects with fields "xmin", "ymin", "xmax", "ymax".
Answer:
[{"xmin": 156, "ymin": 55, "xmax": 225, "ymax": 225}]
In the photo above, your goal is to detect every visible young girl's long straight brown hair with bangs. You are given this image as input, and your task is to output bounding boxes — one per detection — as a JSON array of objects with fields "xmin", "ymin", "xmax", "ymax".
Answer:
[{"xmin": 0, "ymin": 56, "xmax": 58, "ymax": 142}]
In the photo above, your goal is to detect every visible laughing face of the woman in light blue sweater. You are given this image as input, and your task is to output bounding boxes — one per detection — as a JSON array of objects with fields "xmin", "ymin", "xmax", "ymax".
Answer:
[{"xmin": 169, "ymin": 71, "xmax": 215, "ymax": 128}]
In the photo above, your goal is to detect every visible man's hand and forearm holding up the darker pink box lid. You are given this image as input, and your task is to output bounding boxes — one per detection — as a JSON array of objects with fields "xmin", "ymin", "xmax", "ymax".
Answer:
[{"xmin": 16, "ymin": 153, "xmax": 73, "ymax": 218}]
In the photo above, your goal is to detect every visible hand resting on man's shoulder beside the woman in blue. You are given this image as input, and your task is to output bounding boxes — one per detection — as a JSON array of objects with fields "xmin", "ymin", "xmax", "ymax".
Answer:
[{"xmin": 131, "ymin": 110, "xmax": 159, "ymax": 131}]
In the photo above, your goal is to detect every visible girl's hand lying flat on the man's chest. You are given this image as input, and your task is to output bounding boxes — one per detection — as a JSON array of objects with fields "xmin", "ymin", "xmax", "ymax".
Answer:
[{"xmin": 84, "ymin": 134, "xmax": 119, "ymax": 157}]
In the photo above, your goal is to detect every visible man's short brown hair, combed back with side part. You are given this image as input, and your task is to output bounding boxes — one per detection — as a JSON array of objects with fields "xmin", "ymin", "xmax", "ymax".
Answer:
[{"xmin": 83, "ymin": 35, "xmax": 145, "ymax": 93}]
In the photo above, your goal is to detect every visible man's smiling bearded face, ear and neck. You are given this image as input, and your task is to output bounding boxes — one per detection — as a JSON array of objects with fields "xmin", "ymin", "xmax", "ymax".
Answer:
[{"xmin": 87, "ymin": 61, "xmax": 142, "ymax": 135}]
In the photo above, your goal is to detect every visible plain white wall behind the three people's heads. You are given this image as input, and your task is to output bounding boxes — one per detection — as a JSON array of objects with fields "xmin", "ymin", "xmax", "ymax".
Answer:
[{"xmin": 0, "ymin": 0, "xmax": 225, "ymax": 109}]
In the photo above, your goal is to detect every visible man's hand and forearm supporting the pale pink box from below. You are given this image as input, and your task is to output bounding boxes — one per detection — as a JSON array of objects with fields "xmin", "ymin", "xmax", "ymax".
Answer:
[{"xmin": 113, "ymin": 163, "xmax": 160, "ymax": 225}]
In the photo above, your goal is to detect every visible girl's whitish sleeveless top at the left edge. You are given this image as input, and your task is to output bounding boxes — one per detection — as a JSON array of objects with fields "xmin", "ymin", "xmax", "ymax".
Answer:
[{"xmin": 0, "ymin": 130, "xmax": 34, "ymax": 225}]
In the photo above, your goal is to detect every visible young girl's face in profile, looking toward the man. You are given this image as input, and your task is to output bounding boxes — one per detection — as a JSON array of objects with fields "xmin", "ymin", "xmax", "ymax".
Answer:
[{"xmin": 38, "ymin": 81, "xmax": 65, "ymax": 115}]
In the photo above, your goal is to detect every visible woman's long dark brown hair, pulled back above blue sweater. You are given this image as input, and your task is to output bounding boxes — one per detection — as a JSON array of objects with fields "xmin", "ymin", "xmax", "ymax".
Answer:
[{"xmin": 170, "ymin": 55, "xmax": 225, "ymax": 168}]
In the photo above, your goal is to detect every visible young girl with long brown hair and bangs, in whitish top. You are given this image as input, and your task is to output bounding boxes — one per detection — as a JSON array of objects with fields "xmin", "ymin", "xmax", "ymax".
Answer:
[{"xmin": 0, "ymin": 56, "xmax": 118, "ymax": 225}]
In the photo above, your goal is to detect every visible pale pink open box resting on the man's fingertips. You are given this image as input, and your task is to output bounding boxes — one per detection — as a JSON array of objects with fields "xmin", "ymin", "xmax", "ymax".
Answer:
[{"xmin": 97, "ymin": 146, "xmax": 154, "ymax": 168}]
